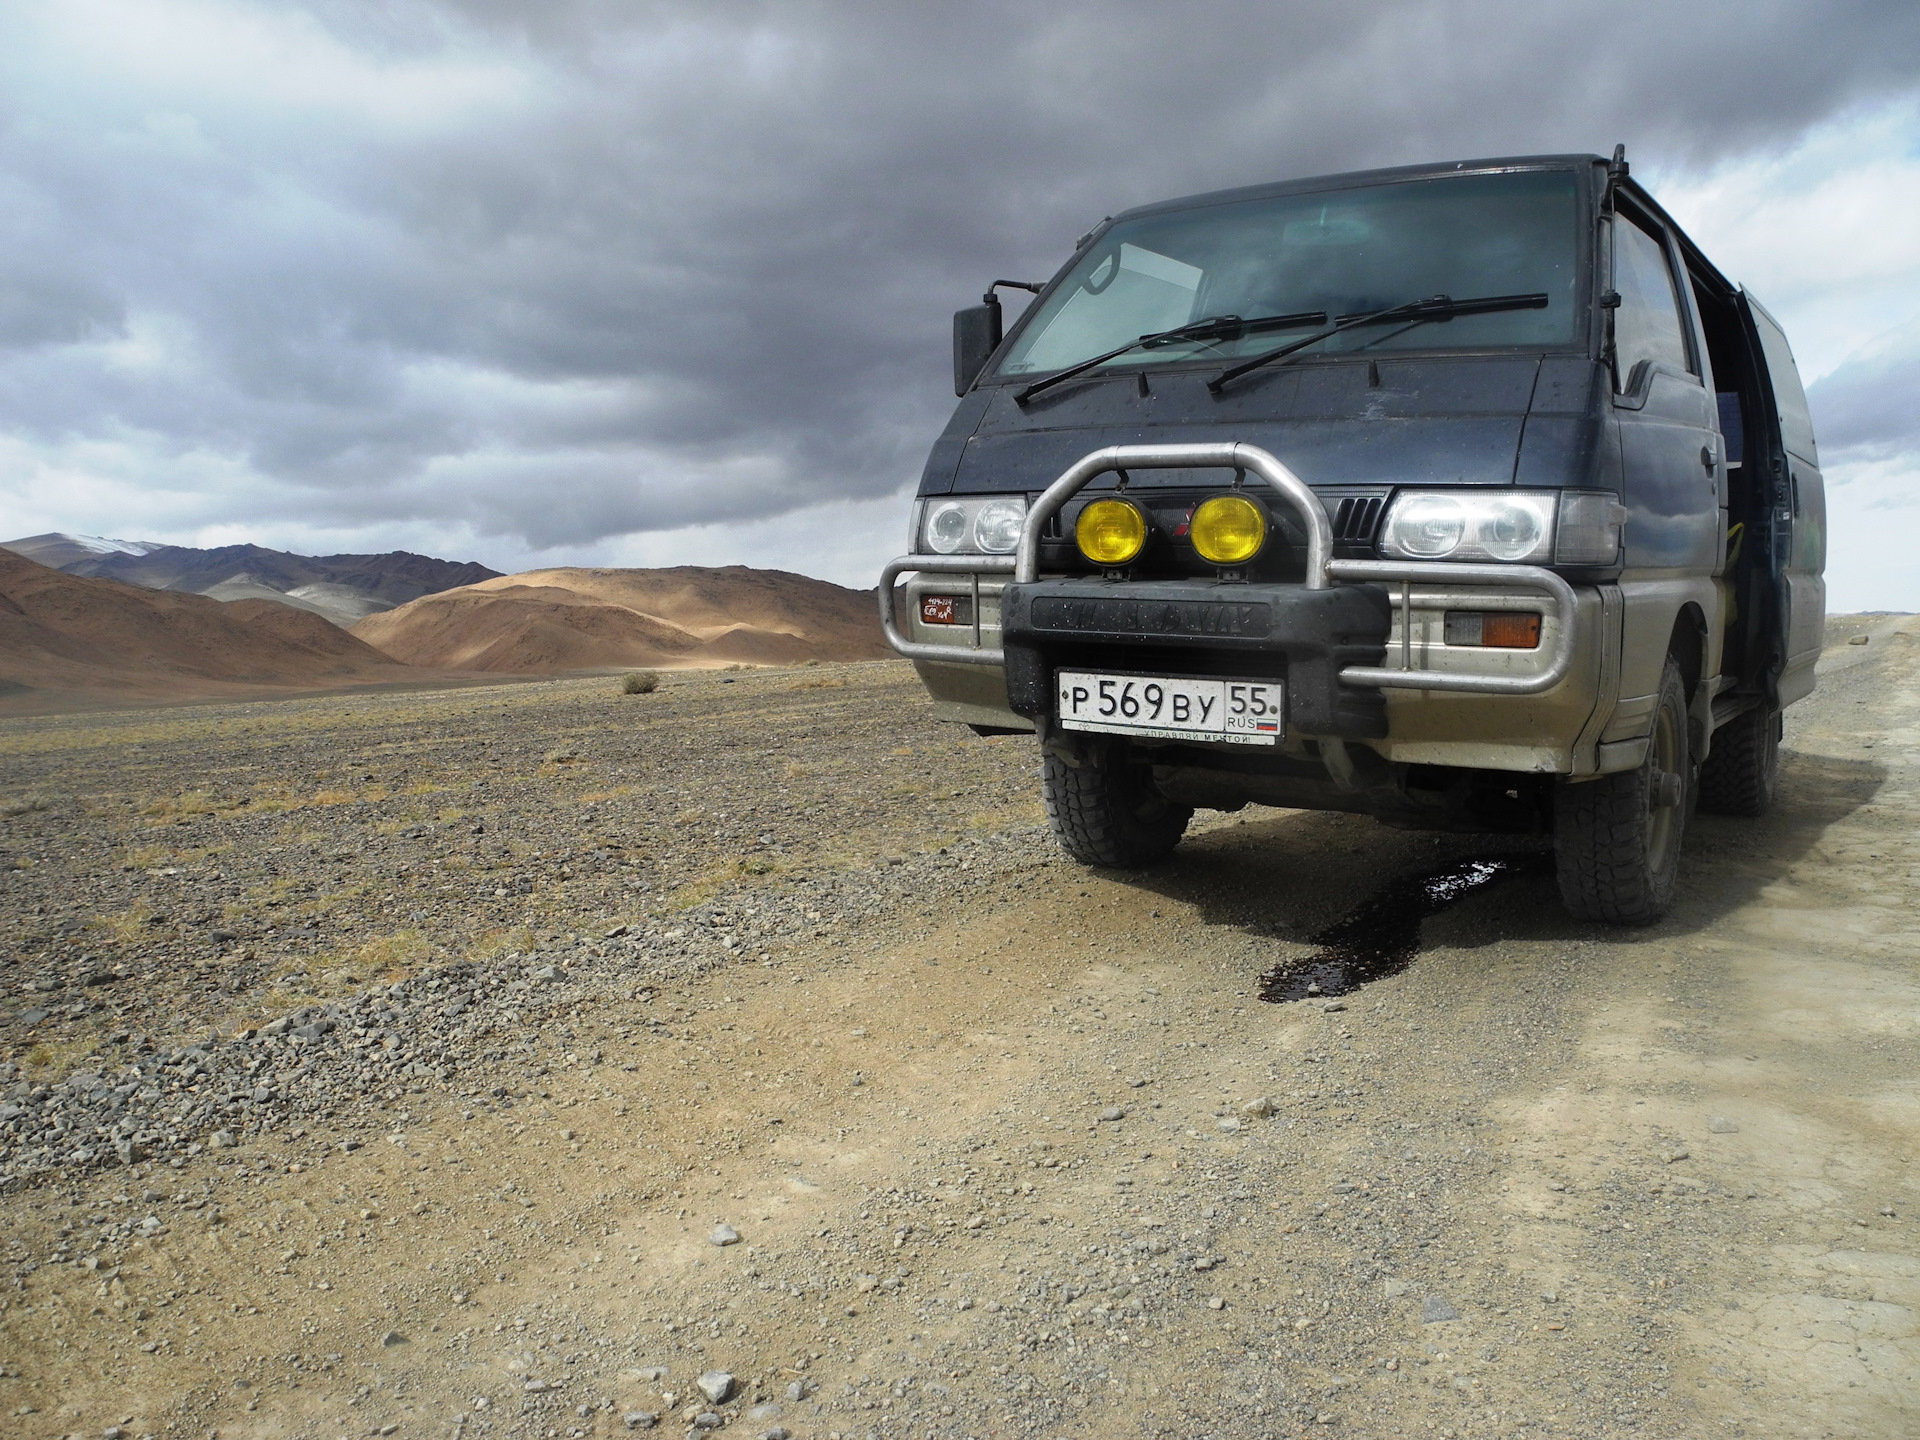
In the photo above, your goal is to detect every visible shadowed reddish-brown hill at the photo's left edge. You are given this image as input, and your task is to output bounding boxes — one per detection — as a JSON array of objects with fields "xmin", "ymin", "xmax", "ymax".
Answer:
[{"xmin": 0, "ymin": 551, "xmax": 413, "ymax": 712}]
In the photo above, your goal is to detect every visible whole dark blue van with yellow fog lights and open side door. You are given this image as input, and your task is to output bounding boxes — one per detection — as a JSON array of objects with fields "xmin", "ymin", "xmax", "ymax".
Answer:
[{"xmin": 881, "ymin": 152, "xmax": 1826, "ymax": 924}]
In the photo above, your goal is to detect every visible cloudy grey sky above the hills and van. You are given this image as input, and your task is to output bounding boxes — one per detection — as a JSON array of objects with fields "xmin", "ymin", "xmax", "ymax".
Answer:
[{"xmin": 0, "ymin": 0, "xmax": 1920, "ymax": 609}]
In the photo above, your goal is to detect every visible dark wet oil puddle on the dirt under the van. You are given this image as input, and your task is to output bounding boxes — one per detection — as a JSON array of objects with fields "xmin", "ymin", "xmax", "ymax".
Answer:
[{"xmin": 1260, "ymin": 854, "xmax": 1553, "ymax": 1004}]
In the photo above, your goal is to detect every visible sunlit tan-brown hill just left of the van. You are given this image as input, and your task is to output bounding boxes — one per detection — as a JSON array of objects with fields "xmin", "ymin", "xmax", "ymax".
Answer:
[{"xmin": 353, "ymin": 564, "xmax": 891, "ymax": 674}]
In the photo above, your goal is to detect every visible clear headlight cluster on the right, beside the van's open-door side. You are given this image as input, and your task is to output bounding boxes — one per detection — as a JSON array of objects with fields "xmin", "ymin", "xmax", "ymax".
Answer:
[{"xmin": 1380, "ymin": 490, "xmax": 1624, "ymax": 564}]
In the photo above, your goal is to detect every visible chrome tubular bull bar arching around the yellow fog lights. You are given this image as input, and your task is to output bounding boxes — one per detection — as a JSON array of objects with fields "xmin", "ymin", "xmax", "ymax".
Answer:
[{"xmin": 879, "ymin": 442, "xmax": 1578, "ymax": 695}]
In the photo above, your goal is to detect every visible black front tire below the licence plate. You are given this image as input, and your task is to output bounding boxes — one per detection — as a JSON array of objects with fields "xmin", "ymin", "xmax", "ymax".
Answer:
[{"xmin": 1041, "ymin": 735, "xmax": 1194, "ymax": 870}]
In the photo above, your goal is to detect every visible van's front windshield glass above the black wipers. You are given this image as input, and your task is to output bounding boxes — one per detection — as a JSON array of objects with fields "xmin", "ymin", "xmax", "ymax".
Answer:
[{"xmin": 998, "ymin": 171, "xmax": 1584, "ymax": 376}]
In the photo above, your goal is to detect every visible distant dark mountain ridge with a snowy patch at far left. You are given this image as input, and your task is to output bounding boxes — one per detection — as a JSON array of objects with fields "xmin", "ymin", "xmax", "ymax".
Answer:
[{"xmin": 0, "ymin": 532, "xmax": 499, "ymax": 626}]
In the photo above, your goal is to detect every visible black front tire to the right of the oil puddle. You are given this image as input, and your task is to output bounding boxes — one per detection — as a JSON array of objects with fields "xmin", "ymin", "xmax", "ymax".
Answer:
[{"xmin": 1553, "ymin": 657, "xmax": 1693, "ymax": 925}]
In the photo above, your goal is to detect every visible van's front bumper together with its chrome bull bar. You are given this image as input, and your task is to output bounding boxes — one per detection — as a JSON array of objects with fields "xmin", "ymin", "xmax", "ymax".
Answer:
[{"xmin": 879, "ymin": 444, "xmax": 1630, "ymax": 774}]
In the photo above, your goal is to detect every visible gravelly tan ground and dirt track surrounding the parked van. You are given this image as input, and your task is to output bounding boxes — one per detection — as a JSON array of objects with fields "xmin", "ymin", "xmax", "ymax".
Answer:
[{"xmin": 0, "ymin": 618, "xmax": 1920, "ymax": 1440}]
